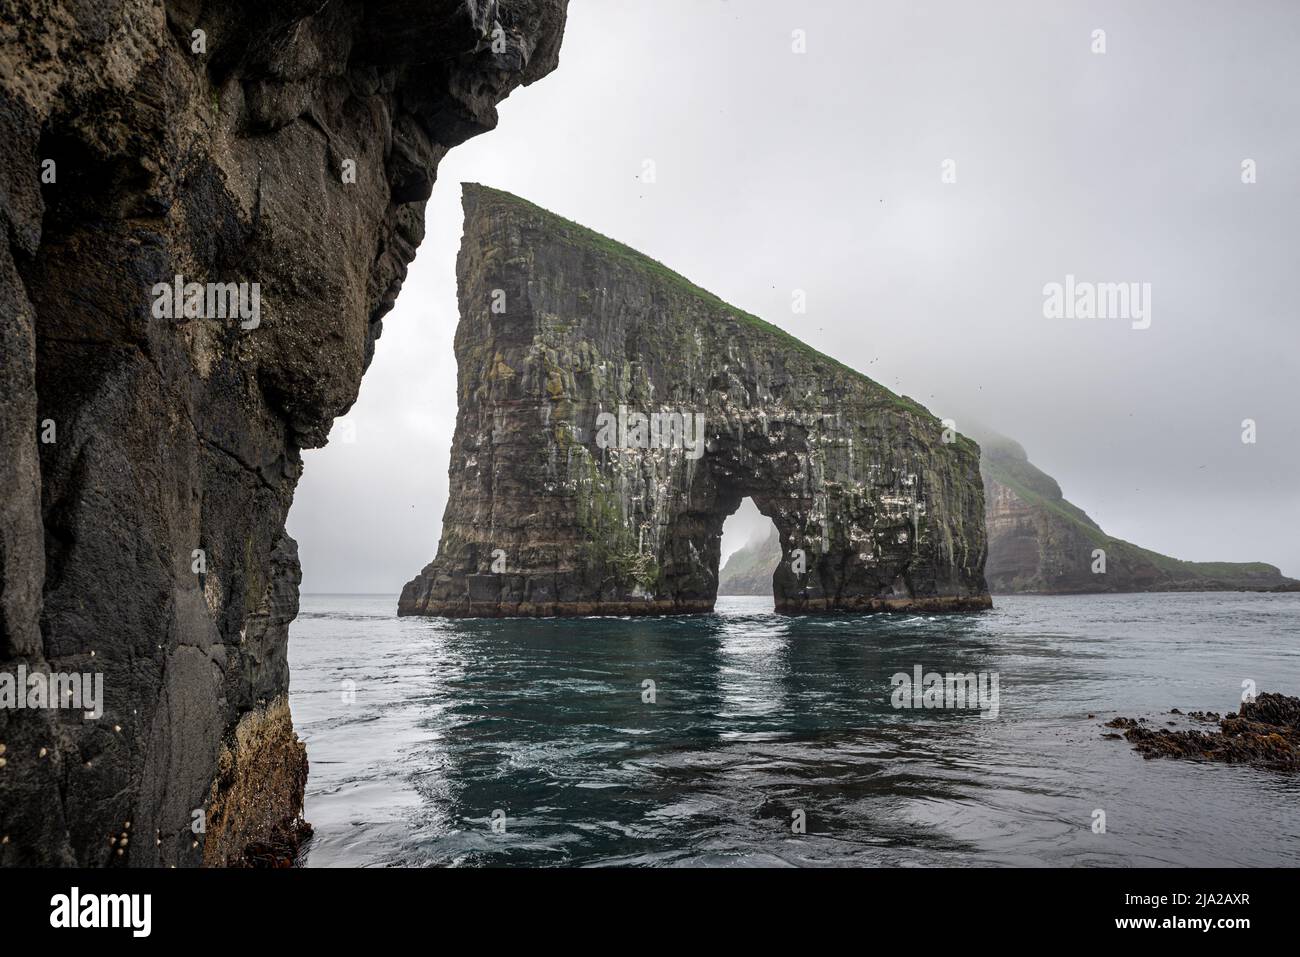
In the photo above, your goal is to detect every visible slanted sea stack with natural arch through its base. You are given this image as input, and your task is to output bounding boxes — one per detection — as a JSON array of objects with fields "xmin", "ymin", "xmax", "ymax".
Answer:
[{"xmin": 399, "ymin": 185, "xmax": 988, "ymax": 616}]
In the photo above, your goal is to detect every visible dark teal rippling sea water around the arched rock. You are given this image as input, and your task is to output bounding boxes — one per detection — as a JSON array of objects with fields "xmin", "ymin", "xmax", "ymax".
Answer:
[{"xmin": 290, "ymin": 593, "xmax": 1300, "ymax": 867}]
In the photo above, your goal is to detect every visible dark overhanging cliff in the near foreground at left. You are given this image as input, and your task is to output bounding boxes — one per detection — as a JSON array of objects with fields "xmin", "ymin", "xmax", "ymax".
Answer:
[{"xmin": 0, "ymin": 0, "xmax": 566, "ymax": 866}]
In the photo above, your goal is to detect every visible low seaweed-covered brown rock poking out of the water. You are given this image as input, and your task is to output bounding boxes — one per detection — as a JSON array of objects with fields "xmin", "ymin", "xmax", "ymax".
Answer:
[{"xmin": 1106, "ymin": 693, "xmax": 1300, "ymax": 772}]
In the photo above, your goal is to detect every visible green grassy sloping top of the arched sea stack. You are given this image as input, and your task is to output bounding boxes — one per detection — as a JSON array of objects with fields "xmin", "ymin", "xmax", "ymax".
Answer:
[{"xmin": 462, "ymin": 183, "xmax": 933, "ymax": 417}]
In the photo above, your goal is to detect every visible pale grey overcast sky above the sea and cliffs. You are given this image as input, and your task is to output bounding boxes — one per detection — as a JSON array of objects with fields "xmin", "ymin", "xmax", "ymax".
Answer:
[{"xmin": 289, "ymin": 0, "xmax": 1300, "ymax": 593}]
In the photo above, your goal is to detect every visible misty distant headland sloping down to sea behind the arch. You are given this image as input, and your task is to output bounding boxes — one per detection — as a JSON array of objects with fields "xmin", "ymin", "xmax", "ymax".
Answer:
[{"xmin": 972, "ymin": 429, "xmax": 1300, "ymax": 594}]
